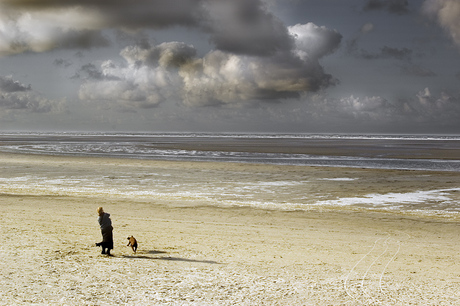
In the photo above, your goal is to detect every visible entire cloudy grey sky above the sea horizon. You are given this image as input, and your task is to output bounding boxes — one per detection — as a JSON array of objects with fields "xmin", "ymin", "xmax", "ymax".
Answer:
[{"xmin": 0, "ymin": 0, "xmax": 460, "ymax": 134}]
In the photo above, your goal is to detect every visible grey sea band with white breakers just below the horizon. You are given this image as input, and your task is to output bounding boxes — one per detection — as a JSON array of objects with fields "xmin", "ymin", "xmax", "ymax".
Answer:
[{"xmin": 0, "ymin": 132, "xmax": 460, "ymax": 172}]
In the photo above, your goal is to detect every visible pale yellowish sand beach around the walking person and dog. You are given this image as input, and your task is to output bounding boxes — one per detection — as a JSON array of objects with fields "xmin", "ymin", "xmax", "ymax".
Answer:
[{"xmin": 0, "ymin": 154, "xmax": 460, "ymax": 305}]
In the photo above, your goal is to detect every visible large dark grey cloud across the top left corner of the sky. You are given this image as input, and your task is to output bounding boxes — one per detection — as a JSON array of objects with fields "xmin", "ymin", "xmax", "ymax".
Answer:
[{"xmin": 0, "ymin": 0, "xmax": 294, "ymax": 56}]
